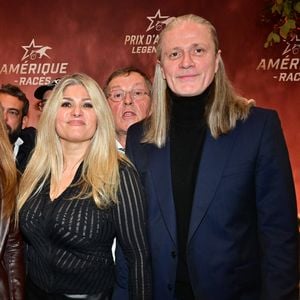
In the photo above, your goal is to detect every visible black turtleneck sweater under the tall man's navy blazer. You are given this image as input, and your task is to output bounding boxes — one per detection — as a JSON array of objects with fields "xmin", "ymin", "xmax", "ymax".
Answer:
[{"xmin": 168, "ymin": 88, "xmax": 209, "ymax": 300}]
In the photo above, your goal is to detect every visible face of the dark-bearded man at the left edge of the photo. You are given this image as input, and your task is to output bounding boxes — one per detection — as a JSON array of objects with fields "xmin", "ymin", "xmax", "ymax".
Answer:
[{"xmin": 0, "ymin": 93, "xmax": 24, "ymax": 143}]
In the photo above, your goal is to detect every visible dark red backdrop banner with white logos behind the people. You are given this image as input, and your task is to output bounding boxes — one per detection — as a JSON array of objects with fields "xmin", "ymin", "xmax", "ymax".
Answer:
[{"xmin": 0, "ymin": 0, "xmax": 300, "ymax": 213}]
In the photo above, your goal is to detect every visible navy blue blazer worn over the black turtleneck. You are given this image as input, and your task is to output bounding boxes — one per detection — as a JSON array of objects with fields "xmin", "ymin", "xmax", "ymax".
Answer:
[{"xmin": 114, "ymin": 108, "xmax": 298, "ymax": 300}]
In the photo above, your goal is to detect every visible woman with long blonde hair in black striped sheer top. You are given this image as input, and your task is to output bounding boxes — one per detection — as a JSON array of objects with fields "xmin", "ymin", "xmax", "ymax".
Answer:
[{"xmin": 18, "ymin": 73, "xmax": 151, "ymax": 300}]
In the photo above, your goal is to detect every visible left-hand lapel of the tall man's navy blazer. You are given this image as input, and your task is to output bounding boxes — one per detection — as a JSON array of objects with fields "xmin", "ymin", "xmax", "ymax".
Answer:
[{"xmin": 149, "ymin": 142, "xmax": 177, "ymax": 244}]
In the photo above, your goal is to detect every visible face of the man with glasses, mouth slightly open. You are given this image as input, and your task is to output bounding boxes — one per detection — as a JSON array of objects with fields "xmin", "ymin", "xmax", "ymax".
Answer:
[{"xmin": 107, "ymin": 72, "xmax": 151, "ymax": 135}]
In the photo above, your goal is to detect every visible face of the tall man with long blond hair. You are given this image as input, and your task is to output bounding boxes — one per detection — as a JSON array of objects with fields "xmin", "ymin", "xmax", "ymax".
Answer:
[{"xmin": 160, "ymin": 21, "xmax": 220, "ymax": 96}]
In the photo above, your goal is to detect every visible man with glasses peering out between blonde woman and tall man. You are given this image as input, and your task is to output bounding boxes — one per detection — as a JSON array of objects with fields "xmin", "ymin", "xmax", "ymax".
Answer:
[{"xmin": 104, "ymin": 67, "xmax": 152, "ymax": 150}]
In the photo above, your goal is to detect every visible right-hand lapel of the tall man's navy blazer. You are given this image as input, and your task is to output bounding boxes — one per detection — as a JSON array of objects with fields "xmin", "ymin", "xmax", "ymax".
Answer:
[{"xmin": 188, "ymin": 131, "xmax": 236, "ymax": 241}]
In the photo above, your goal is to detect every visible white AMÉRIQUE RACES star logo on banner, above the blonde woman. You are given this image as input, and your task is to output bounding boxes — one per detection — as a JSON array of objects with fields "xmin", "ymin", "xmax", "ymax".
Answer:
[{"xmin": 0, "ymin": 38, "xmax": 69, "ymax": 86}]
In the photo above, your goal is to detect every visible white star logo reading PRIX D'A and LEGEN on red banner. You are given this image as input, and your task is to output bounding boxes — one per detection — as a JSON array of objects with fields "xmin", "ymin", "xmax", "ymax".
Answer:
[{"xmin": 124, "ymin": 9, "xmax": 169, "ymax": 54}]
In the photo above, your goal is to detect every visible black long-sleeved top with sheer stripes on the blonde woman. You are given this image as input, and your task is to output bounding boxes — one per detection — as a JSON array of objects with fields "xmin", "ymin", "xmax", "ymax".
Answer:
[{"xmin": 20, "ymin": 166, "xmax": 151, "ymax": 299}]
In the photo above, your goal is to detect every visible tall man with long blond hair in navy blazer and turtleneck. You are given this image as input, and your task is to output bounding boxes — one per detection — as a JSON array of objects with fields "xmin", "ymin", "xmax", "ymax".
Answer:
[{"xmin": 113, "ymin": 15, "xmax": 299, "ymax": 300}]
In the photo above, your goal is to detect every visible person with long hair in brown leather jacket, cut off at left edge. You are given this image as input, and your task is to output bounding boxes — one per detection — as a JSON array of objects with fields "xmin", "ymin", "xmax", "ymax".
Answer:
[{"xmin": 0, "ymin": 108, "xmax": 25, "ymax": 300}]
